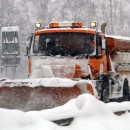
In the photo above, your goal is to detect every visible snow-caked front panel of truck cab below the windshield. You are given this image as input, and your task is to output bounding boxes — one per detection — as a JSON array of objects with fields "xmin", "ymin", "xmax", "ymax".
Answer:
[{"xmin": 31, "ymin": 57, "xmax": 89, "ymax": 79}]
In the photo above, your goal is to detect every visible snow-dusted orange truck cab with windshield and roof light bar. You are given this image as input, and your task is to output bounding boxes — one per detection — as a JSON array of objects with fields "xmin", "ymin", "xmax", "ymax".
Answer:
[{"xmin": 28, "ymin": 22, "xmax": 106, "ymax": 79}]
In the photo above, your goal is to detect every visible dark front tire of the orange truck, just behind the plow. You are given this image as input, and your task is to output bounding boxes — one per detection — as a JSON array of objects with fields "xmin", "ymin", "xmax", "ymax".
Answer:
[{"xmin": 101, "ymin": 76, "xmax": 109, "ymax": 103}]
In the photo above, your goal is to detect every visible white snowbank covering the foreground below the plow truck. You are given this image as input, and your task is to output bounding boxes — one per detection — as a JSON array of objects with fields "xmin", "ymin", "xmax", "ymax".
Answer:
[{"xmin": 0, "ymin": 94, "xmax": 130, "ymax": 130}]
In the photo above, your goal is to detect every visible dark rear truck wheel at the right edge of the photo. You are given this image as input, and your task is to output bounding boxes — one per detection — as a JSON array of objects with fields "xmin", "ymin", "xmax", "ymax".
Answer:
[{"xmin": 123, "ymin": 78, "xmax": 130, "ymax": 101}]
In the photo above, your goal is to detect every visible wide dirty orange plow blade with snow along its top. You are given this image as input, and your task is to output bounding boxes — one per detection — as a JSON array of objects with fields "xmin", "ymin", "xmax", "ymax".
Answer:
[{"xmin": 0, "ymin": 78, "xmax": 81, "ymax": 111}]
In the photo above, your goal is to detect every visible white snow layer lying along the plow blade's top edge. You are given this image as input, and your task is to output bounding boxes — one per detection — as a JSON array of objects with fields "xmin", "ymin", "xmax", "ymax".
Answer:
[{"xmin": 0, "ymin": 78, "xmax": 77, "ymax": 87}]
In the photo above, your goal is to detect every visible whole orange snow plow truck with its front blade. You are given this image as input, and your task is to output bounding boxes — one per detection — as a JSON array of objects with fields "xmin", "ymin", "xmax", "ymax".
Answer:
[{"xmin": 0, "ymin": 22, "xmax": 130, "ymax": 111}]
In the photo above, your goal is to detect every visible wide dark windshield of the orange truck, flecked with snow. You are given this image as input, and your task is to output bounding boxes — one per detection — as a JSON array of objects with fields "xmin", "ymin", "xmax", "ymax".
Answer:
[{"xmin": 33, "ymin": 32, "xmax": 95, "ymax": 56}]
